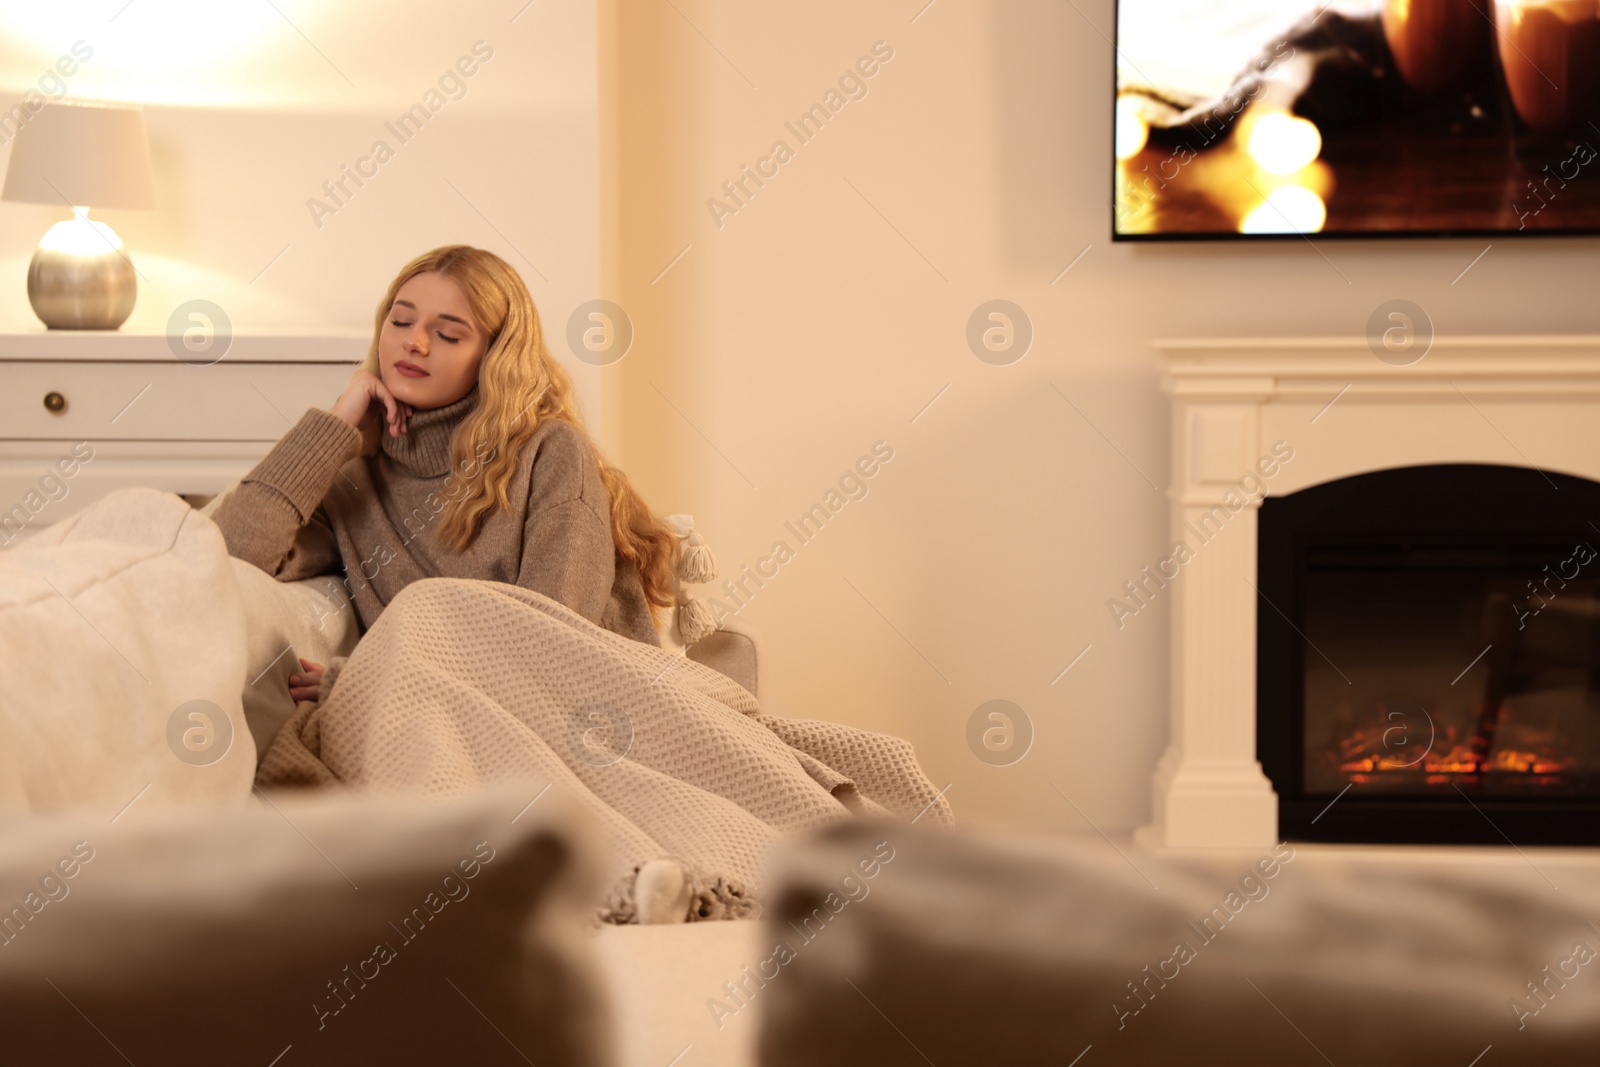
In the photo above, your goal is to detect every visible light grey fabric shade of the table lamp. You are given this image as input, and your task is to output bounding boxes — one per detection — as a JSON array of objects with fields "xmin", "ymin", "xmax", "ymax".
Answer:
[{"xmin": 0, "ymin": 101, "xmax": 155, "ymax": 210}]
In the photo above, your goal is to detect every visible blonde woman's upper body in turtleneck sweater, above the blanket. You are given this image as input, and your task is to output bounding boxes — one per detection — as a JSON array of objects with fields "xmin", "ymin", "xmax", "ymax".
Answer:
[{"xmin": 213, "ymin": 245, "xmax": 677, "ymax": 701}]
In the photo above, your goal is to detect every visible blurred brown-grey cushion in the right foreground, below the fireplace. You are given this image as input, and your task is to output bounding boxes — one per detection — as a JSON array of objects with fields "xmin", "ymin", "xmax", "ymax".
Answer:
[{"xmin": 755, "ymin": 821, "xmax": 1600, "ymax": 1067}]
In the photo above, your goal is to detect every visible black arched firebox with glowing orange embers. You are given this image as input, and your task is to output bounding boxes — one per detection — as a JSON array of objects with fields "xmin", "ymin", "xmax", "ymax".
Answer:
[{"xmin": 1256, "ymin": 464, "xmax": 1600, "ymax": 845}]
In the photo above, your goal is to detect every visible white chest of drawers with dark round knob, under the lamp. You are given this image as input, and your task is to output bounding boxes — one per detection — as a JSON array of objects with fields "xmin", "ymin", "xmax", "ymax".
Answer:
[{"xmin": 0, "ymin": 330, "xmax": 370, "ymax": 549}]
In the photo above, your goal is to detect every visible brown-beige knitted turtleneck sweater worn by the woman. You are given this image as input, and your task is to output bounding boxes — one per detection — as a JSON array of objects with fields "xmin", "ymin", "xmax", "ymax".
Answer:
[{"xmin": 213, "ymin": 386, "xmax": 661, "ymax": 668}]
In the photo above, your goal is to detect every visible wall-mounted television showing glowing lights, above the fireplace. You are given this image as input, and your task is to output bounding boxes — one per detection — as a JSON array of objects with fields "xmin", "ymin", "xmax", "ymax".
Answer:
[{"xmin": 1112, "ymin": 0, "xmax": 1600, "ymax": 240}]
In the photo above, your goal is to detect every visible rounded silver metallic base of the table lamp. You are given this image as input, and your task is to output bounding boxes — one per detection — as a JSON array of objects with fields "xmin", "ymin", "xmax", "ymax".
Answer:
[{"xmin": 27, "ymin": 208, "xmax": 138, "ymax": 330}]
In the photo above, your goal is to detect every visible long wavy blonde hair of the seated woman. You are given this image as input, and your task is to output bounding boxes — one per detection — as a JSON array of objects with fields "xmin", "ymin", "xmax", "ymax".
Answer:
[{"xmin": 362, "ymin": 245, "xmax": 678, "ymax": 625}]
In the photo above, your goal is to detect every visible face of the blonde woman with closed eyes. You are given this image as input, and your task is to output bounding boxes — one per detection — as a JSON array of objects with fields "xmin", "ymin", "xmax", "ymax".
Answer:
[{"xmin": 378, "ymin": 270, "xmax": 488, "ymax": 411}]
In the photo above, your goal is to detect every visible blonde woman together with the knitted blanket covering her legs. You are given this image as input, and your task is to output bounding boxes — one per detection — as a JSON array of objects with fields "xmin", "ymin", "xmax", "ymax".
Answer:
[{"xmin": 224, "ymin": 245, "xmax": 947, "ymax": 921}]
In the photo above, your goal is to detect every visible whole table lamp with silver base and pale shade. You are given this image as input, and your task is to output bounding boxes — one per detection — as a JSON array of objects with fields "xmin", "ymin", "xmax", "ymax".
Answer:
[{"xmin": 0, "ymin": 101, "xmax": 155, "ymax": 330}]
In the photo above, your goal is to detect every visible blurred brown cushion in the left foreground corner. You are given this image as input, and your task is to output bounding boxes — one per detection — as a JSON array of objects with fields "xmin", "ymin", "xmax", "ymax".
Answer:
[{"xmin": 0, "ymin": 785, "xmax": 614, "ymax": 1067}]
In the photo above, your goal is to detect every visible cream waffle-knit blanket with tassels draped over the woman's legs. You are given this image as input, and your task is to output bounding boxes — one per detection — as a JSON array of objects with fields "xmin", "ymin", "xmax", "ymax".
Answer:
[{"xmin": 256, "ymin": 577, "xmax": 950, "ymax": 923}]
